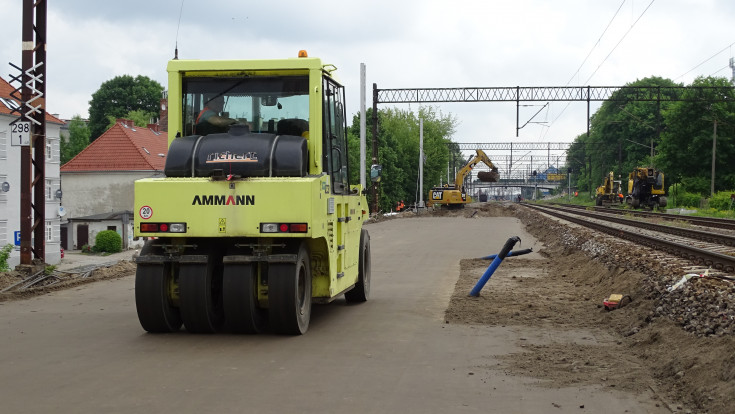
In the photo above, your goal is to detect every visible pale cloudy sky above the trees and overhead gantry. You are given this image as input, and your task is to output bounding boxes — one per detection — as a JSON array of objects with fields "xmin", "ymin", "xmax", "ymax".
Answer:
[{"xmin": 0, "ymin": 0, "xmax": 735, "ymax": 149}]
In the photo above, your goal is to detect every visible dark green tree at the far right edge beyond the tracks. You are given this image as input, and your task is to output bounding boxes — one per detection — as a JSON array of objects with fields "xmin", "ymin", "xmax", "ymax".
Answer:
[{"xmin": 656, "ymin": 77, "xmax": 735, "ymax": 195}]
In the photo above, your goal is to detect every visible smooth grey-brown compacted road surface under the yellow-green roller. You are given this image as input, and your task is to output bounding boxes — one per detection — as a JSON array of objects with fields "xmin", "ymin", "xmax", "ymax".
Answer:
[{"xmin": 0, "ymin": 217, "xmax": 664, "ymax": 414}]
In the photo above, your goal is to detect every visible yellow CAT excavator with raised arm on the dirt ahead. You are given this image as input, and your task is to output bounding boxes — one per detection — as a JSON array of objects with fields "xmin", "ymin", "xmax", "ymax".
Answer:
[{"xmin": 426, "ymin": 149, "xmax": 500, "ymax": 208}]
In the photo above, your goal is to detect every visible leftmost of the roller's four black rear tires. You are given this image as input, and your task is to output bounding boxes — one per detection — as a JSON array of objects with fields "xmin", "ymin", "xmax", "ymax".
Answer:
[{"xmin": 135, "ymin": 263, "xmax": 181, "ymax": 333}]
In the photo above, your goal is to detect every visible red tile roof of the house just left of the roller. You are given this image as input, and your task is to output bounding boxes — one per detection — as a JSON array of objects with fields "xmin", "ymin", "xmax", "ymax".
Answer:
[{"xmin": 61, "ymin": 119, "xmax": 168, "ymax": 172}]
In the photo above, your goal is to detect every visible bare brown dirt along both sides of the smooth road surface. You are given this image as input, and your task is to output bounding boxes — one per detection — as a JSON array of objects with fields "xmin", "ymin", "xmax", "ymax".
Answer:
[{"xmin": 5, "ymin": 203, "xmax": 735, "ymax": 414}]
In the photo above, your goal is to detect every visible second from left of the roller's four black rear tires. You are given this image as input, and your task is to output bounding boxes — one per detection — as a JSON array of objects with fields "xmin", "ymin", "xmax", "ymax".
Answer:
[{"xmin": 179, "ymin": 254, "xmax": 224, "ymax": 333}]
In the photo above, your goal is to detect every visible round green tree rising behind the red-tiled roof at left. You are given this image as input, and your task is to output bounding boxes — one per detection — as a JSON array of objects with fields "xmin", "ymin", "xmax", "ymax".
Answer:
[{"xmin": 89, "ymin": 75, "xmax": 163, "ymax": 140}]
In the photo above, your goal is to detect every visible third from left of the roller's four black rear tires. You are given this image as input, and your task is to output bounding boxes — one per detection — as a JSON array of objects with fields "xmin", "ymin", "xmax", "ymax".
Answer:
[{"xmin": 227, "ymin": 263, "xmax": 267, "ymax": 334}]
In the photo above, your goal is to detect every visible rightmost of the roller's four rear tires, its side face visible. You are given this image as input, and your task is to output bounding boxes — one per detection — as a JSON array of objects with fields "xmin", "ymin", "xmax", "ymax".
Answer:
[{"xmin": 268, "ymin": 243, "xmax": 311, "ymax": 335}]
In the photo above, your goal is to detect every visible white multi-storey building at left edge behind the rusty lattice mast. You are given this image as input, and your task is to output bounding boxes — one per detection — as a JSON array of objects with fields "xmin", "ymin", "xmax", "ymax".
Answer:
[{"xmin": 0, "ymin": 78, "xmax": 64, "ymax": 268}]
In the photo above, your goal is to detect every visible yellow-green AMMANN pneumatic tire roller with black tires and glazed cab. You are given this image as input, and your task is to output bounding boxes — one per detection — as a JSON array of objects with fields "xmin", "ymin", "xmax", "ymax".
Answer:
[{"xmin": 135, "ymin": 51, "xmax": 370, "ymax": 335}]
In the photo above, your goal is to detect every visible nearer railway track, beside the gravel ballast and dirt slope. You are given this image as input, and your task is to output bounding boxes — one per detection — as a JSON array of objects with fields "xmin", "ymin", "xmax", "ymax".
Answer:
[{"xmin": 524, "ymin": 204, "xmax": 735, "ymax": 280}]
